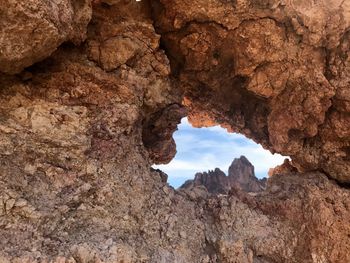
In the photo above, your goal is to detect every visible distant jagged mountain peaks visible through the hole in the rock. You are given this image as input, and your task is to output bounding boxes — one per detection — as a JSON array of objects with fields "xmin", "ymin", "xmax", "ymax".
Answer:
[{"xmin": 180, "ymin": 156, "xmax": 266, "ymax": 194}]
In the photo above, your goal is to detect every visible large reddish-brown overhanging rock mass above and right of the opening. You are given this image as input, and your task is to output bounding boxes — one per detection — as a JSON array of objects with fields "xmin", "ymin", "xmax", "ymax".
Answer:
[{"xmin": 153, "ymin": 0, "xmax": 350, "ymax": 182}]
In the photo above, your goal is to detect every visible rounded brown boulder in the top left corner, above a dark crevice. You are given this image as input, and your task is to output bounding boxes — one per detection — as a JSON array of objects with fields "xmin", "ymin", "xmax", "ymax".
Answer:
[{"xmin": 0, "ymin": 0, "xmax": 91, "ymax": 74}]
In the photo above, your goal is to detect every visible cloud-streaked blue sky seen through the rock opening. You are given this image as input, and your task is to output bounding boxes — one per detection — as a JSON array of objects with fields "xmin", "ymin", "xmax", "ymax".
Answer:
[{"xmin": 153, "ymin": 118, "xmax": 286, "ymax": 188}]
